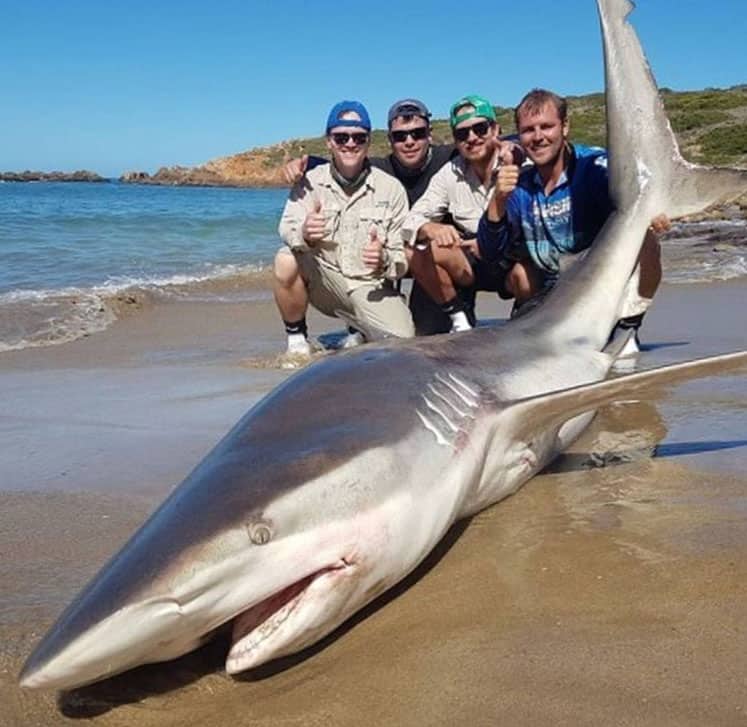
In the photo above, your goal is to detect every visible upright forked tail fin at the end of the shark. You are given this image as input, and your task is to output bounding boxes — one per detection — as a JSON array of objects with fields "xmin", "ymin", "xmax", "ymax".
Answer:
[{"xmin": 597, "ymin": 0, "xmax": 747, "ymax": 218}]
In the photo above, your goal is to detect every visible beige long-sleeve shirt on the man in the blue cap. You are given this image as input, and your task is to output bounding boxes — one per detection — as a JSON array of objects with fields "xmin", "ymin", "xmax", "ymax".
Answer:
[{"xmin": 279, "ymin": 164, "xmax": 408, "ymax": 281}]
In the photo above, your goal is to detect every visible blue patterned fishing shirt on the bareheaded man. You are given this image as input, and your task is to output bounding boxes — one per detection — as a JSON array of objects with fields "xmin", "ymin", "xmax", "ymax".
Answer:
[{"xmin": 477, "ymin": 144, "xmax": 614, "ymax": 279}]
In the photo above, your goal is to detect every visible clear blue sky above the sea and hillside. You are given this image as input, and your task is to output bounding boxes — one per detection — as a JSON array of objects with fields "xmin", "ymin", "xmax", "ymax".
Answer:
[{"xmin": 0, "ymin": 0, "xmax": 747, "ymax": 176}]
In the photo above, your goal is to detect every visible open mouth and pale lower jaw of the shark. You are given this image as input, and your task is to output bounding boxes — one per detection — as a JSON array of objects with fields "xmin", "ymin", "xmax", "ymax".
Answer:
[{"xmin": 226, "ymin": 558, "xmax": 355, "ymax": 674}]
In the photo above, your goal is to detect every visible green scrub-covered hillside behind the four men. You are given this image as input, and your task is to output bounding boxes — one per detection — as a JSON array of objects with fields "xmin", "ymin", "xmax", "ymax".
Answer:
[{"xmin": 256, "ymin": 85, "xmax": 747, "ymax": 170}]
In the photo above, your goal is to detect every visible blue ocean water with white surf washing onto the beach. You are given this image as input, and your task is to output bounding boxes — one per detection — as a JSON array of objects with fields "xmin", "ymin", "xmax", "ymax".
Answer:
[{"xmin": 0, "ymin": 182, "xmax": 747, "ymax": 351}]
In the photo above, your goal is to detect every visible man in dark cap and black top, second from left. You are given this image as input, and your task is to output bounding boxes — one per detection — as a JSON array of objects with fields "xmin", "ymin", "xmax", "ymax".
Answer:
[{"xmin": 283, "ymin": 98, "xmax": 462, "ymax": 335}]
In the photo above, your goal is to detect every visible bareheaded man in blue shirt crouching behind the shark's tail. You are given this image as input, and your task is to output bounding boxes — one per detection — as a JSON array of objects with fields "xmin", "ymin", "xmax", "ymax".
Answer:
[{"xmin": 477, "ymin": 89, "xmax": 669, "ymax": 348}]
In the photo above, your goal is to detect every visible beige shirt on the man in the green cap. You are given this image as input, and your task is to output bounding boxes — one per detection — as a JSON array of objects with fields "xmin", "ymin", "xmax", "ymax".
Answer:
[{"xmin": 402, "ymin": 157, "xmax": 493, "ymax": 245}]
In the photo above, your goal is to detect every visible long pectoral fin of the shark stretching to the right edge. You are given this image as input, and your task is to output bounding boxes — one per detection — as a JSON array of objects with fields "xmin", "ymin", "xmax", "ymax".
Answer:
[{"xmin": 512, "ymin": 351, "xmax": 747, "ymax": 432}]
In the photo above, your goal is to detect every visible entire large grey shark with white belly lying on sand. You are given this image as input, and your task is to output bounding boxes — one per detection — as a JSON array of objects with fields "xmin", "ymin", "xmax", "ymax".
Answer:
[{"xmin": 20, "ymin": 0, "xmax": 747, "ymax": 689}]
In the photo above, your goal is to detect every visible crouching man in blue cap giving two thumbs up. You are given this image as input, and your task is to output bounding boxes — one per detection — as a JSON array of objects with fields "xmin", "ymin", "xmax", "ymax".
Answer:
[{"xmin": 274, "ymin": 101, "xmax": 415, "ymax": 358}]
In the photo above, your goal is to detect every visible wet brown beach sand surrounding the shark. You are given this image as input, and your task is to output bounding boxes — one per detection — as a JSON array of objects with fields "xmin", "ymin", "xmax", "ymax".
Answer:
[{"xmin": 0, "ymin": 283, "xmax": 747, "ymax": 726}]
